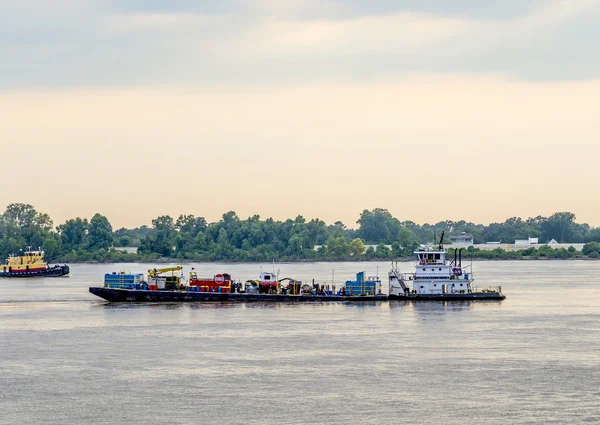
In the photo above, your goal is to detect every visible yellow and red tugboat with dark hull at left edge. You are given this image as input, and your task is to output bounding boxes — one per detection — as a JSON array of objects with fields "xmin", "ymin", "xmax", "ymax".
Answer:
[{"xmin": 0, "ymin": 246, "xmax": 69, "ymax": 277}]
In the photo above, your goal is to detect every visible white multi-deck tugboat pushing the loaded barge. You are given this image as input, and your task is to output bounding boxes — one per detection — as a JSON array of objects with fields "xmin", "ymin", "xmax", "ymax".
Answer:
[{"xmin": 389, "ymin": 233, "xmax": 506, "ymax": 301}]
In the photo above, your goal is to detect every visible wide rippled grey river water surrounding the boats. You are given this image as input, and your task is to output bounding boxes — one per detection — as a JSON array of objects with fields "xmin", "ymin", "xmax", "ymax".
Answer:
[{"xmin": 0, "ymin": 261, "xmax": 600, "ymax": 425}]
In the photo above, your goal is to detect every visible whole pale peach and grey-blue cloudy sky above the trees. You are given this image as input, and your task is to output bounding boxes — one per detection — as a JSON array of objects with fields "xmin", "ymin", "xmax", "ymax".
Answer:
[{"xmin": 0, "ymin": 0, "xmax": 600, "ymax": 228}]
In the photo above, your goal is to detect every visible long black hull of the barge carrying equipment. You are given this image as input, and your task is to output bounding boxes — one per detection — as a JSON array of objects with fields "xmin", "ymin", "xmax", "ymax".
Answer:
[{"xmin": 89, "ymin": 286, "xmax": 388, "ymax": 303}]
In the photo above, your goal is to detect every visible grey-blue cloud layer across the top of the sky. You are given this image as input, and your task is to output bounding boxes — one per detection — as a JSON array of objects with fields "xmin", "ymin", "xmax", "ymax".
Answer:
[{"xmin": 0, "ymin": 0, "xmax": 600, "ymax": 89}]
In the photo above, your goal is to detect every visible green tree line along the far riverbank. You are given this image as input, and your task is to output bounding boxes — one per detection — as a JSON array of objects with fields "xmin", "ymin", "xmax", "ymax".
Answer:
[{"xmin": 0, "ymin": 203, "xmax": 600, "ymax": 262}]
